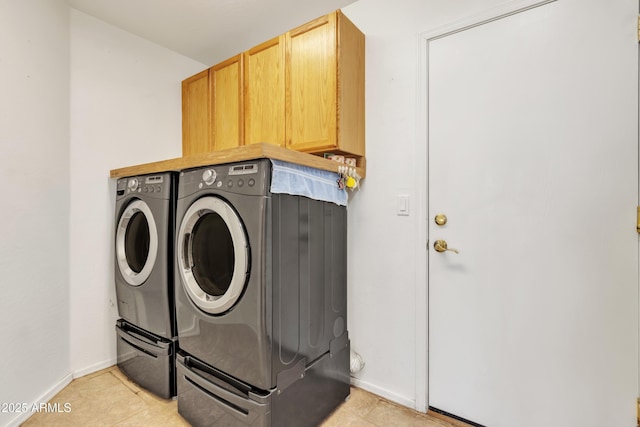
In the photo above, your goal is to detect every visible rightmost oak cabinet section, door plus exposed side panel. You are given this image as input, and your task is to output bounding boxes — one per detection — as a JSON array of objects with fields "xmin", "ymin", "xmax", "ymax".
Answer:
[{"xmin": 286, "ymin": 11, "xmax": 365, "ymax": 162}]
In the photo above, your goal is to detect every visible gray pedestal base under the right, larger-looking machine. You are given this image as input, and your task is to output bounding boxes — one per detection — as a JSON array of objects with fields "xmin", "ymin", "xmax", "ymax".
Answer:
[{"xmin": 176, "ymin": 341, "xmax": 349, "ymax": 427}]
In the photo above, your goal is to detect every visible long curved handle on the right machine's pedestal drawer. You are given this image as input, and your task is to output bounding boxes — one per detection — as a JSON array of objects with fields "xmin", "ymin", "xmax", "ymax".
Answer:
[{"xmin": 177, "ymin": 359, "xmax": 270, "ymax": 425}]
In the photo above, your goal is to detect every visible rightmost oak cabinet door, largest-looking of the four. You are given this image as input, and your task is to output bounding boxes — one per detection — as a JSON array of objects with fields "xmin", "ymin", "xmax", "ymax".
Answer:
[{"xmin": 286, "ymin": 13, "xmax": 337, "ymax": 152}]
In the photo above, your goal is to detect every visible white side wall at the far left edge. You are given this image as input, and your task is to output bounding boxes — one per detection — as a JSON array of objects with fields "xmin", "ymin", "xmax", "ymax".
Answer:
[{"xmin": 0, "ymin": 0, "xmax": 69, "ymax": 425}]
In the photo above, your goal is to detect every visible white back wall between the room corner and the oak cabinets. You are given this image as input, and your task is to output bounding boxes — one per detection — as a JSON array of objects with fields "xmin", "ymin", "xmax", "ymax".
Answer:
[{"xmin": 70, "ymin": 9, "xmax": 206, "ymax": 376}]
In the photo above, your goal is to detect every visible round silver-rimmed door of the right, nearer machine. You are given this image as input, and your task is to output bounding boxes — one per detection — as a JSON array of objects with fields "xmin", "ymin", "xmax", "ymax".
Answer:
[{"xmin": 177, "ymin": 196, "xmax": 249, "ymax": 314}]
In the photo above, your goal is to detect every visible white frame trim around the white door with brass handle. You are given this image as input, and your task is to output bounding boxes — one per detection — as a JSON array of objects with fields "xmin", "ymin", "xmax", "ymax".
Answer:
[{"xmin": 414, "ymin": 0, "xmax": 557, "ymax": 412}]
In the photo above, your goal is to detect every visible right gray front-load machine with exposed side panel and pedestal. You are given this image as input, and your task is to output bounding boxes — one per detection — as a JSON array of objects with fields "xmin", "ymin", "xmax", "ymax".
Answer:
[{"xmin": 175, "ymin": 159, "xmax": 349, "ymax": 426}]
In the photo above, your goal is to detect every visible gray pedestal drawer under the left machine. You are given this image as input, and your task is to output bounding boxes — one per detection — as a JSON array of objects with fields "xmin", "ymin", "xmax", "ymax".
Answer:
[{"xmin": 116, "ymin": 319, "xmax": 176, "ymax": 399}]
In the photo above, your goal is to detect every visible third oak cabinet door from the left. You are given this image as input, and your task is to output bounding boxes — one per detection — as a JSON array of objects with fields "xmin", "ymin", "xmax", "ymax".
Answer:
[{"xmin": 244, "ymin": 35, "xmax": 285, "ymax": 147}]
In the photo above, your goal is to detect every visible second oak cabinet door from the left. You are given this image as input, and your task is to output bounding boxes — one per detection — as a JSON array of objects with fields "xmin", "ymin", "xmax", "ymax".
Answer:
[{"xmin": 209, "ymin": 55, "xmax": 243, "ymax": 150}]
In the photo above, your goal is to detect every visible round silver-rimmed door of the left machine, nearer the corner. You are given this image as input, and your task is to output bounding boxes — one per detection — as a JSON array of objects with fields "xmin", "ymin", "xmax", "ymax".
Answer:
[{"xmin": 116, "ymin": 199, "xmax": 158, "ymax": 286}]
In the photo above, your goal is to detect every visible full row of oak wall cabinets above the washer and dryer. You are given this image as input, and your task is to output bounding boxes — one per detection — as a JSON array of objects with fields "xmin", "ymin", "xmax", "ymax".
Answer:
[{"xmin": 182, "ymin": 10, "xmax": 365, "ymax": 166}]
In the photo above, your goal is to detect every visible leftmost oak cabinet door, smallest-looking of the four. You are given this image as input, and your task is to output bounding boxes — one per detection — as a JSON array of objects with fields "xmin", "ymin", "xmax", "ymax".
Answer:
[{"xmin": 182, "ymin": 70, "xmax": 212, "ymax": 156}]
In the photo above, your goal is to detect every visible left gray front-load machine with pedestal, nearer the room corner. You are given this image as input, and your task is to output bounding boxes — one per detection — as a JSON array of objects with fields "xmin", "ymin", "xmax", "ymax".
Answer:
[{"xmin": 114, "ymin": 172, "xmax": 176, "ymax": 398}]
